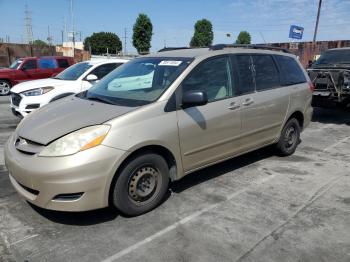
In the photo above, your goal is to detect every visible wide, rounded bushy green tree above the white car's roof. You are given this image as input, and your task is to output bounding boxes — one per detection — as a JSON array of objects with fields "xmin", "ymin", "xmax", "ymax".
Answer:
[{"xmin": 84, "ymin": 32, "xmax": 122, "ymax": 55}]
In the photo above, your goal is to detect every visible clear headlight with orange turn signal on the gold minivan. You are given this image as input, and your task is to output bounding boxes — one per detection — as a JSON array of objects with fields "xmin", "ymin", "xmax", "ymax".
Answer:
[{"xmin": 39, "ymin": 125, "xmax": 110, "ymax": 156}]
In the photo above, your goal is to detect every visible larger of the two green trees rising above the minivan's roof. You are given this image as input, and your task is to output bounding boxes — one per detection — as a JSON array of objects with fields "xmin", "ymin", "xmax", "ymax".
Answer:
[{"xmin": 190, "ymin": 19, "xmax": 214, "ymax": 47}]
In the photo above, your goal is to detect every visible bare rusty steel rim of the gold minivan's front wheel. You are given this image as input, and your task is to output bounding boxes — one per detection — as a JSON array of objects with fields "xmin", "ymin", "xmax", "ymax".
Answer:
[{"xmin": 129, "ymin": 166, "xmax": 160, "ymax": 202}]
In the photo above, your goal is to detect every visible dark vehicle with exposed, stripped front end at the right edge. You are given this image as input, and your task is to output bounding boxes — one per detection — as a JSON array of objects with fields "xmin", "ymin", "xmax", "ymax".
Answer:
[{"xmin": 308, "ymin": 48, "xmax": 350, "ymax": 107}]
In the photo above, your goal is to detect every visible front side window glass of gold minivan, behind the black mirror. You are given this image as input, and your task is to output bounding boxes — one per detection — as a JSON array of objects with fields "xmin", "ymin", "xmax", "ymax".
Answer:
[{"xmin": 181, "ymin": 56, "xmax": 232, "ymax": 102}]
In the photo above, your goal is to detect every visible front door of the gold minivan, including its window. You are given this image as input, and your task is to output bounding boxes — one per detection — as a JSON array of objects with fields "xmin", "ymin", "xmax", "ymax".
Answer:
[{"xmin": 177, "ymin": 56, "xmax": 241, "ymax": 172}]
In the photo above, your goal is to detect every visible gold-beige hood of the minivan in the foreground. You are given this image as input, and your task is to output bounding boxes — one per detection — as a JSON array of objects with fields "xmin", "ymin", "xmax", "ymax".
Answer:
[{"xmin": 17, "ymin": 96, "xmax": 137, "ymax": 145}]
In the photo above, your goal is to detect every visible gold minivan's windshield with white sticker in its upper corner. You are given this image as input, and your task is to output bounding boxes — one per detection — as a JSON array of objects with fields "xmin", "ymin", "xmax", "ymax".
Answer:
[{"xmin": 84, "ymin": 57, "xmax": 192, "ymax": 106}]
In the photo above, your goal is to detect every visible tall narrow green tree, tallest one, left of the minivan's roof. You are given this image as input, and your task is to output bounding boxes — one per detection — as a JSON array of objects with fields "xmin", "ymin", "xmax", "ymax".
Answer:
[{"xmin": 132, "ymin": 14, "xmax": 153, "ymax": 54}]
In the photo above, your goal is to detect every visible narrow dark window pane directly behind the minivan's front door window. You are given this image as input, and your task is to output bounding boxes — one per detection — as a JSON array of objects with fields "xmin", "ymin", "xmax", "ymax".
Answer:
[{"xmin": 232, "ymin": 55, "xmax": 255, "ymax": 95}]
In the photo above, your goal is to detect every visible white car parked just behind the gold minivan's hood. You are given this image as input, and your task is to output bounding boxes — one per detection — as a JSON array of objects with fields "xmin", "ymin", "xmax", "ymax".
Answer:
[{"xmin": 10, "ymin": 59, "xmax": 129, "ymax": 117}]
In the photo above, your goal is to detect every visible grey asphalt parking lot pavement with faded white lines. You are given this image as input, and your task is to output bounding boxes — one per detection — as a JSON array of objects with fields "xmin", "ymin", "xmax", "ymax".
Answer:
[{"xmin": 0, "ymin": 94, "xmax": 350, "ymax": 262}]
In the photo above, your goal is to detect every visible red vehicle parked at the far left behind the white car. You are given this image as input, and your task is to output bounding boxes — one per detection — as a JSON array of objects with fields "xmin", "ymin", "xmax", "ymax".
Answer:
[{"xmin": 0, "ymin": 56, "xmax": 74, "ymax": 95}]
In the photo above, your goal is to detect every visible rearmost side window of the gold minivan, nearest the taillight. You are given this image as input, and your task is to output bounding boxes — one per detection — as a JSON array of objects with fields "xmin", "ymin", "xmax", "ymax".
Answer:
[{"xmin": 275, "ymin": 55, "xmax": 306, "ymax": 86}]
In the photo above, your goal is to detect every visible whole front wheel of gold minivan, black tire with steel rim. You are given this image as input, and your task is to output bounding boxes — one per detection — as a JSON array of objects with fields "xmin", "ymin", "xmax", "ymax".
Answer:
[{"xmin": 112, "ymin": 152, "xmax": 169, "ymax": 216}]
